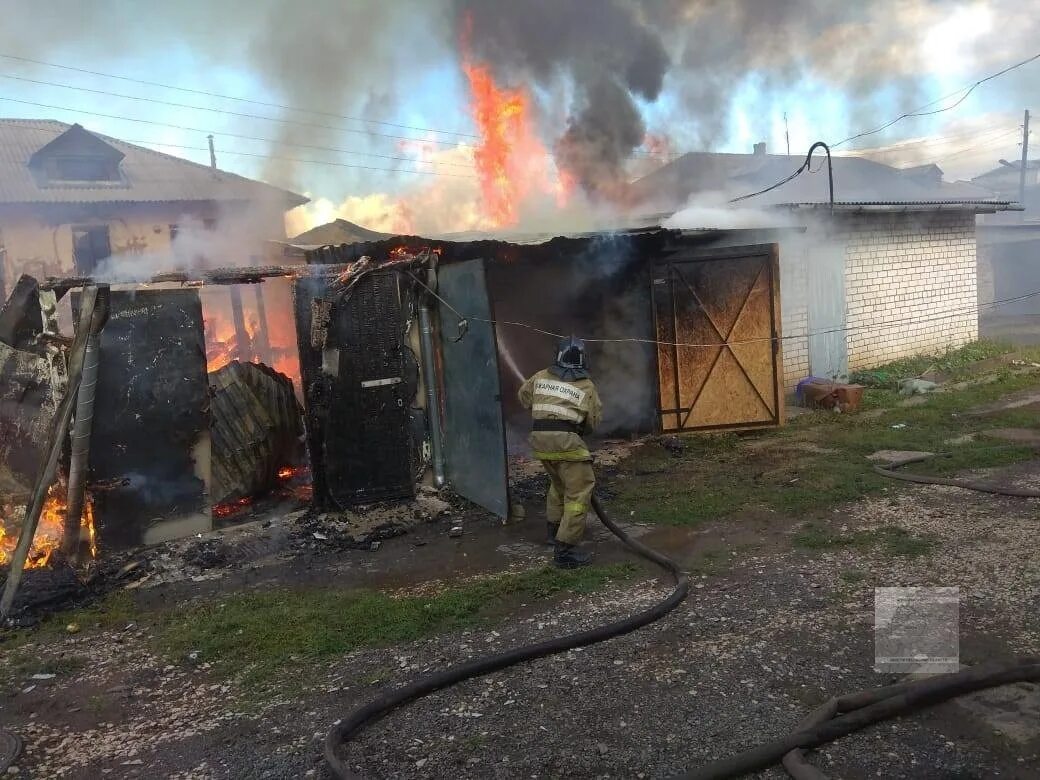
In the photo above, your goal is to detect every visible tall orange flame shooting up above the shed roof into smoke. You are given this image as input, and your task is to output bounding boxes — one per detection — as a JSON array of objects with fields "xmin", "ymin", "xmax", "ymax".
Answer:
[{"xmin": 461, "ymin": 19, "xmax": 574, "ymax": 228}]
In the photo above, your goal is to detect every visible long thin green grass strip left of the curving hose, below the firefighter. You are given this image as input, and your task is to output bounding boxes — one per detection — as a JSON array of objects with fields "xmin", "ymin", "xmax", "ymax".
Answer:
[{"xmin": 149, "ymin": 565, "xmax": 636, "ymax": 682}]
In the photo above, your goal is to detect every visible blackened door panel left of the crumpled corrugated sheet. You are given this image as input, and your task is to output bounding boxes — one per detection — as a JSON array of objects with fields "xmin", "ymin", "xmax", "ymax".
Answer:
[{"xmin": 82, "ymin": 290, "xmax": 210, "ymax": 549}]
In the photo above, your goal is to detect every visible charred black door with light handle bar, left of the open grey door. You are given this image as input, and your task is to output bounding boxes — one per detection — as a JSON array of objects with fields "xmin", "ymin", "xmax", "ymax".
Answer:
[{"xmin": 294, "ymin": 271, "xmax": 418, "ymax": 508}]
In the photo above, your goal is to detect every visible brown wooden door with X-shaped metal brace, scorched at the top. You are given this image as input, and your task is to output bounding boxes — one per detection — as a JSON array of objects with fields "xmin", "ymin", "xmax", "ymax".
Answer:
[{"xmin": 652, "ymin": 244, "xmax": 783, "ymax": 431}]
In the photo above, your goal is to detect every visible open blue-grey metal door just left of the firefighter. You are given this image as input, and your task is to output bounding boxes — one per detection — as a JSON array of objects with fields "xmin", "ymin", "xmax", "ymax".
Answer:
[{"xmin": 438, "ymin": 260, "xmax": 509, "ymax": 518}]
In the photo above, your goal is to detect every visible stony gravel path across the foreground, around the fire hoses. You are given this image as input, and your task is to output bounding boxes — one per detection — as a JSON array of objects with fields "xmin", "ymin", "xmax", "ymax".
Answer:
[{"xmin": 0, "ymin": 464, "xmax": 1040, "ymax": 780}]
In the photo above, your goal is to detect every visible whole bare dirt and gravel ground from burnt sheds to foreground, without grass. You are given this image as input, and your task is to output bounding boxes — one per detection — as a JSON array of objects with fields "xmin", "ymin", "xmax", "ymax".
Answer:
[{"xmin": 0, "ymin": 366, "xmax": 1040, "ymax": 780}]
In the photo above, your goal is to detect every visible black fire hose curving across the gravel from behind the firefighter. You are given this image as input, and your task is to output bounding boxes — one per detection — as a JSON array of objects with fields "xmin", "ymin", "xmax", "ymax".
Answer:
[{"xmin": 324, "ymin": 496, "xmax": 690, "ymax": 780}]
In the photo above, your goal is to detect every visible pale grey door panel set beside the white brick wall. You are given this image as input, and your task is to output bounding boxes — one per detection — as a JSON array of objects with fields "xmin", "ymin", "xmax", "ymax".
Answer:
[{"xmin": 808, "ymin": 244, "xmax": 849, "ymax": 381}]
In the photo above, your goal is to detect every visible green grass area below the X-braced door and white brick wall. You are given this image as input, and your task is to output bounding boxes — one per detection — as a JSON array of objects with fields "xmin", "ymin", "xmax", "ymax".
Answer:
[{"xmin": 612, "ymin": 342, "xmax": 1040, "ymax": 526}]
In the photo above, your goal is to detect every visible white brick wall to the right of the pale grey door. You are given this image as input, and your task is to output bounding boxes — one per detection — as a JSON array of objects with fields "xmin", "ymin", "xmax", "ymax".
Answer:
[{"xmin": 832, "ymin": 212, "xmax": 979, "ymax": 370}]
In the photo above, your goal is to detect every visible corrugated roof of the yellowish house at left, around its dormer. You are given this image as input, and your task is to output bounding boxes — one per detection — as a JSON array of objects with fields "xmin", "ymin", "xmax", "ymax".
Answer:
[{"xmin": 0, "ymin": 119, "xmax": 308, "ymax": 209}]
